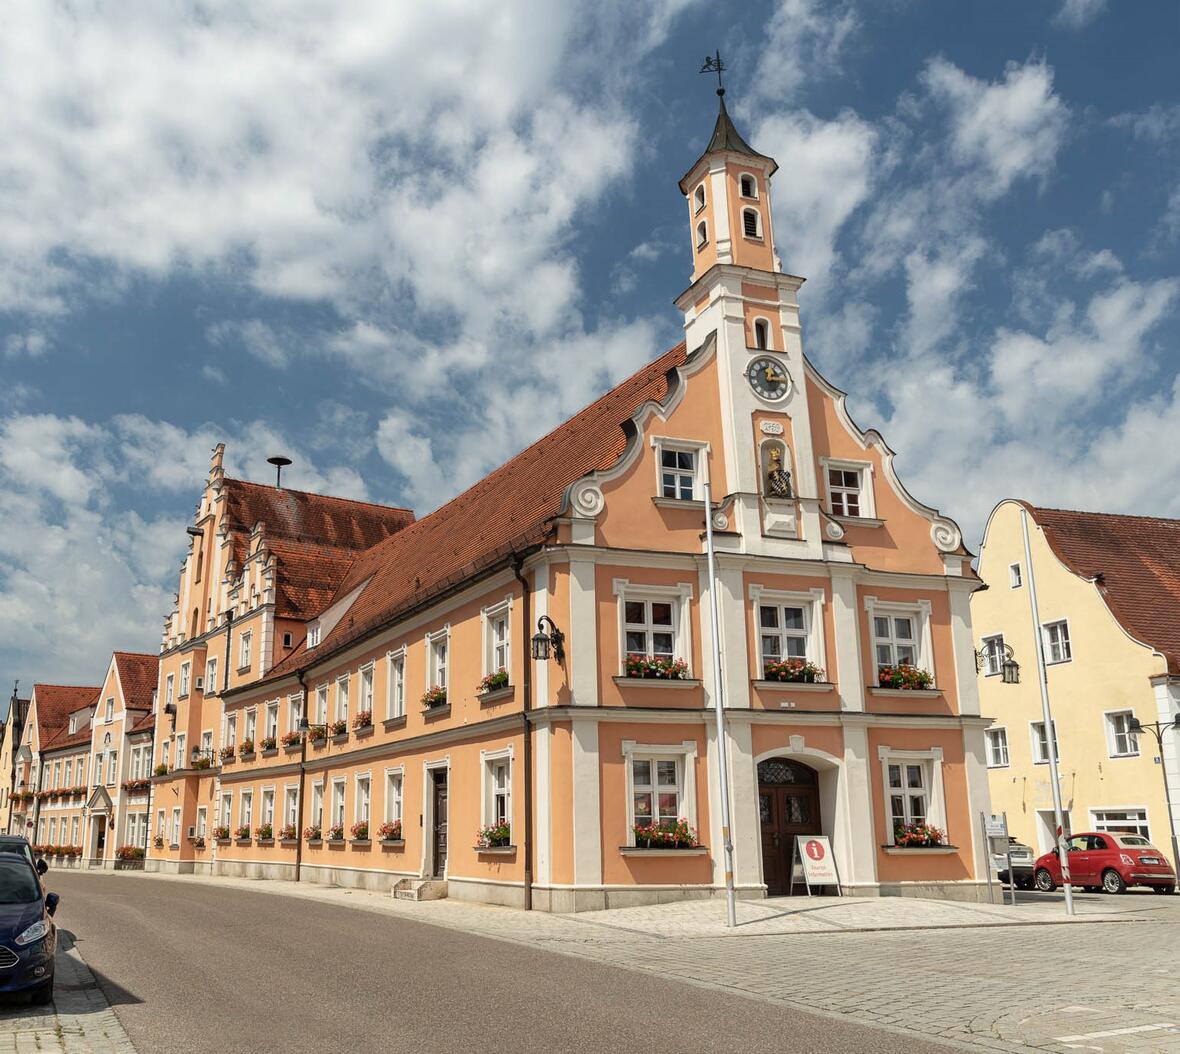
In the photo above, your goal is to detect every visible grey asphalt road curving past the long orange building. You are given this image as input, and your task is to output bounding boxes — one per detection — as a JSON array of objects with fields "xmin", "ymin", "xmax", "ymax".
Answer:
[{"xmin": 43, "ymin": 872, "xmax": 948, "ymax": 1054}]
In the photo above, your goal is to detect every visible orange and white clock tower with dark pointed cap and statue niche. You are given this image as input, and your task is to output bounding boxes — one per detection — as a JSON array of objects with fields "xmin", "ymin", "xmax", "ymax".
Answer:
[{"xmin": 676, "ymin": 89, "xmax": 838, "ymax": 559}]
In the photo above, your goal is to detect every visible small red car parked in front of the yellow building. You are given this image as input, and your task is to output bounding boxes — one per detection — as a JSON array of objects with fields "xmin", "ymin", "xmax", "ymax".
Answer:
[{"xmin": 1033, "ymin": 831, "xmax": 1176, "ymax": 893}]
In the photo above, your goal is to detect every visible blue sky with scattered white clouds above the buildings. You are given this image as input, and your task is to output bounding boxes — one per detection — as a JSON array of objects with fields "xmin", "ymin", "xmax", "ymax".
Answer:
[{"xmin": 0, "ymin": 0, "xmax": 1180, "ymax": 694}]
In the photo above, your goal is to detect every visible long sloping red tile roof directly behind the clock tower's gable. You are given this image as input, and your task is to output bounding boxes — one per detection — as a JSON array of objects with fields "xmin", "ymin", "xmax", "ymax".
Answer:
[{"xmin": 267, "ymin": 345, "xmax": 687, "ymax": 680}]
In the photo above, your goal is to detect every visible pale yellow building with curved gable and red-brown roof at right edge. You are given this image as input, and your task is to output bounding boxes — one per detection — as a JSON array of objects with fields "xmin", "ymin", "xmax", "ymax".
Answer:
[{"xmin": 971, "ymin": 499, "xmax": 1180, "ymax": 862}]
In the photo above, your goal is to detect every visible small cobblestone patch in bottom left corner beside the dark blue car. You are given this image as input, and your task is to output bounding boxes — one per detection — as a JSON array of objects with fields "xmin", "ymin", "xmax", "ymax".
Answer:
[{"xmin": 0, "ymin": 930, "xmax": 136, "ymax": 1054}]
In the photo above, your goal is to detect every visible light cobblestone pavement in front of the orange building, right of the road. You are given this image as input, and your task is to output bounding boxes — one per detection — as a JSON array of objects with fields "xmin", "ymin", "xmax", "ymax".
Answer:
[{"xmin": 23, "ymin": 875, "xmax": 1180, "ymax": 1054}]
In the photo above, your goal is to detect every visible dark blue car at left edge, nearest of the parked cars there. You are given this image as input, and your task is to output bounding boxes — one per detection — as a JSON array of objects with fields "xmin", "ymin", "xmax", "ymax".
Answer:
[{"xmin": 0, "ymin": 853, "xmax": 59, "ymax": 1003}]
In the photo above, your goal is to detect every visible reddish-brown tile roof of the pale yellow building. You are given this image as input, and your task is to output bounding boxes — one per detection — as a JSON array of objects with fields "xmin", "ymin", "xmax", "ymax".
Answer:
[{"xmin": 1024, "ymin": 503, "xmax": 1180, "ymax": 675}]
